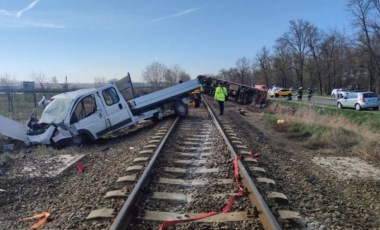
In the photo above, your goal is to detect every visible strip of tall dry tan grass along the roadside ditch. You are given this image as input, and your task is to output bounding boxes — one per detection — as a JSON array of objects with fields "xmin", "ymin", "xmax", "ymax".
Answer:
[{"xmin": 267, "ymin": 104, "xmax": 380, "ymax": 164}]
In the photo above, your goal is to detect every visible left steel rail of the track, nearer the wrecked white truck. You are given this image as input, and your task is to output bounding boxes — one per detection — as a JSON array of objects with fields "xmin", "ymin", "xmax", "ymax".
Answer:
[{"xmin": 110, "ymin": 117, "xmax": 179, "ymax": 230}]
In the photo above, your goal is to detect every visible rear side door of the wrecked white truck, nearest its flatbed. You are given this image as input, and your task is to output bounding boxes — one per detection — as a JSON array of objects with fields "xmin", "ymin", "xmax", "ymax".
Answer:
[{"xmin": 101, "ymin": 87, "xmax": 132, "ymax": 131}]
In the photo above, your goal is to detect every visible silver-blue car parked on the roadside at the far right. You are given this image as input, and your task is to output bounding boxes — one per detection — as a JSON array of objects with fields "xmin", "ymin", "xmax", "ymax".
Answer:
[{"xmin": 336, "ymin": 92, "xmax": 379, "ymax": 110}]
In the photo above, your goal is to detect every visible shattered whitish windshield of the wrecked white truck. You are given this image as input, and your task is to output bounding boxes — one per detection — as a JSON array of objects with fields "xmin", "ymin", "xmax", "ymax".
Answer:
[{"xmin": 39, "ymin": 98, "xmax": 72, "ymax": 124}]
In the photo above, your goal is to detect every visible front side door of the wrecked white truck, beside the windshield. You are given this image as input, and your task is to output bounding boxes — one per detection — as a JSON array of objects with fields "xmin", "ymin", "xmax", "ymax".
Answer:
[{"xmin": 70, "ymin": 94, "xmax": 108, "ymax": 139}]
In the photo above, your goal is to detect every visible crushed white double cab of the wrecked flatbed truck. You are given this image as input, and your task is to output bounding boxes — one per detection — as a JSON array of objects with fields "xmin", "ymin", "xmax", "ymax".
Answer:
[{"xmin": 27, "ymin": 84, "xmax": 133, "ymax": 144}]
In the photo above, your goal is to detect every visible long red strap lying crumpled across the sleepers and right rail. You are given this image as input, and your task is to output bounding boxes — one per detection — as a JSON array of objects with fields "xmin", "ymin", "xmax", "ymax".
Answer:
[{"xmin": 158, "ymin": 152, "xmax": 261, "ymax": 230}]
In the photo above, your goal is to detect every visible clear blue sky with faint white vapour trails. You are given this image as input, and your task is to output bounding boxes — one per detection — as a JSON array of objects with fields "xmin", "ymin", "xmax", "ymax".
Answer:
[{"xmin": 0, "ymin": 0, "xmax": 351, "ymax": 83}]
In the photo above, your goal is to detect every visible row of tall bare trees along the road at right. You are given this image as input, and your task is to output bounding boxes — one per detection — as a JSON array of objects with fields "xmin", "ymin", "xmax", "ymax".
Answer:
[{"xmin": 209, "ymin": 0, "xmax": 380, "ymax": 94}]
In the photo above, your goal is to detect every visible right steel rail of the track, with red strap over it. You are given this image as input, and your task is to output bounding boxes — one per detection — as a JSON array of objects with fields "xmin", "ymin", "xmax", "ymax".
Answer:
[{"xmin": 202, "ymin": 97, "xmax": 281, "ymax": 229}]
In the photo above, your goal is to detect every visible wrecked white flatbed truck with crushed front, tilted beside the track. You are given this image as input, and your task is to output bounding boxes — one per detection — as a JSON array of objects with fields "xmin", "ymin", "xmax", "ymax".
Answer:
[{"xmin": 0, "ymin": 74, "xmax": 199, "ymax": 147}]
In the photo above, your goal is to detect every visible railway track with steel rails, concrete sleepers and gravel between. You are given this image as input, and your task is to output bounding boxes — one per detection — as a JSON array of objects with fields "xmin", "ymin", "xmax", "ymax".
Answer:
[{"xmin": 87, "ymin": 98, "xmax": 300, "ymax": 229}]
